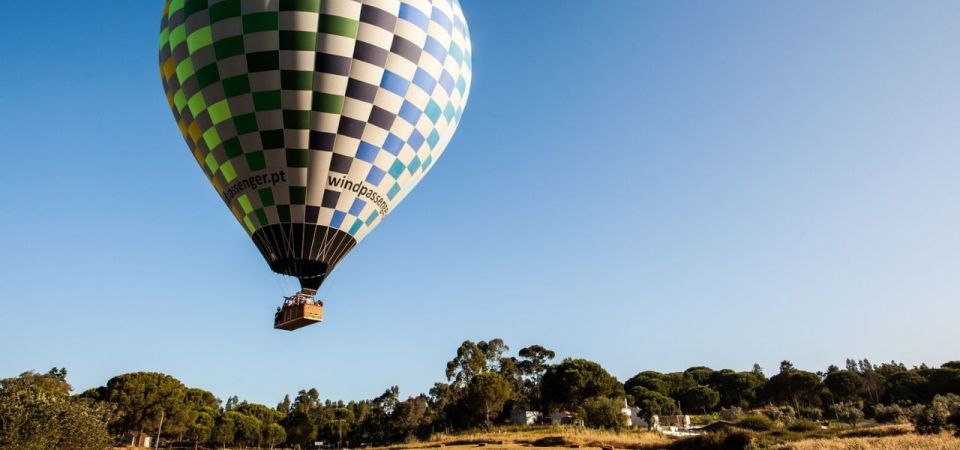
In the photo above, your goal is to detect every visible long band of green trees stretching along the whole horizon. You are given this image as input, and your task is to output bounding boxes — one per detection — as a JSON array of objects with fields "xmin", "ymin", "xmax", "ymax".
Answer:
[{"xmin": 0, "ymin": 339, "xmax": 960, "ymax": 450}]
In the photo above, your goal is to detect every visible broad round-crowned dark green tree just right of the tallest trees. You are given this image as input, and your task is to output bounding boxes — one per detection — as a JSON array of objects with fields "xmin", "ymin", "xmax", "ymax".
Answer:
[{"xmin": 540, "ymin": 358, "xmax": 624, "ymax": 409}]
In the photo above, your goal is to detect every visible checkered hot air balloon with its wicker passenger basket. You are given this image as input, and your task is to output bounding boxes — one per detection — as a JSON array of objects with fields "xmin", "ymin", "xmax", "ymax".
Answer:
[{"xmin": 160, "ymin": 0, "xmax": 471, "ymax": 330}]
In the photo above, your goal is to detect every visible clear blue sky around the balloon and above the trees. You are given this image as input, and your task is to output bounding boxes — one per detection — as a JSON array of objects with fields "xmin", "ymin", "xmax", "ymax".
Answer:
[{"xmin": 0, "ymin": 0, "xmax": 960, "ymax": 405}]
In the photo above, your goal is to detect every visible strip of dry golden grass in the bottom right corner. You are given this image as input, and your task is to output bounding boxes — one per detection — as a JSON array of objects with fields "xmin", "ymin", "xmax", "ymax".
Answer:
[{"xmin": 781, "ymin": 433, "xmax": 960, "ymax": 450}]
